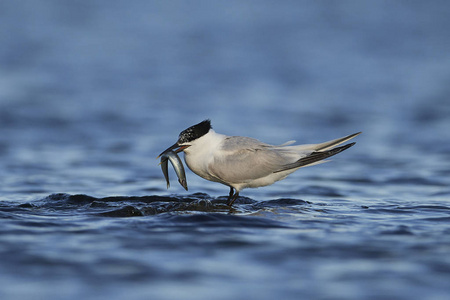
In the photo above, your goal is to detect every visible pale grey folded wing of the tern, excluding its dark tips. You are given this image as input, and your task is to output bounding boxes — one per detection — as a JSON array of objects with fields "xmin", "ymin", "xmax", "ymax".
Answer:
[{"xmin": 209, "ymin": 137, "xmax": 295, "ymax": 183}]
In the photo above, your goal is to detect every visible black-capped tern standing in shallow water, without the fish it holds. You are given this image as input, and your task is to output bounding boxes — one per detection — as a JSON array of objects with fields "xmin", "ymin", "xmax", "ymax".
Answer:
[{"xmin": 158, "ymin": 119, "xmax": 361, "ymax": 207}]
